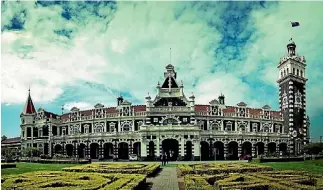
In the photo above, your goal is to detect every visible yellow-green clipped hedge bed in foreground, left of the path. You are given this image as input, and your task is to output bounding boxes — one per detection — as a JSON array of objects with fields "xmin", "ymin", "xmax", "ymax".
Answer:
[{"xmin": 1, "ymin": 171, "xmax": 146, "ymax": 190}]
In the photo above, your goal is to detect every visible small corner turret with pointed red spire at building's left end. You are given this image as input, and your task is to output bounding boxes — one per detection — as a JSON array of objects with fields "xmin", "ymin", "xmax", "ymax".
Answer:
[{"xmin": 20, "ymin": 89, "xmax": 36, "ymax": 139}]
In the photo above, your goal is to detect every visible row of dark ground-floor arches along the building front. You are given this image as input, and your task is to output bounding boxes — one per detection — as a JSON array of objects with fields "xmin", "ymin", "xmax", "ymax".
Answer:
[{"xmin": 53, "ymin": 139, "xmax": 288, "ymax": 161}]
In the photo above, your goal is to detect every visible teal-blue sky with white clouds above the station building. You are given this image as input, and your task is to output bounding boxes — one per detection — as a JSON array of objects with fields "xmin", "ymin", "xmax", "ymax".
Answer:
[{"xmin": 1, "ymin": 1, "xmax": 323, "ymax": 139}]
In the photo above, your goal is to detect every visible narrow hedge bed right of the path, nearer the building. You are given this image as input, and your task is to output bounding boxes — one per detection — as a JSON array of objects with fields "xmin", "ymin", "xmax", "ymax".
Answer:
[{"xmin": 177, "ymin": 163, "xmax": 273, "ymax": 176}]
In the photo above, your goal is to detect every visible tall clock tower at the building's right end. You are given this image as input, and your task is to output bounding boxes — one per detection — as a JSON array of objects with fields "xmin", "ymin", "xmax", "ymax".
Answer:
[{"xmin": 277, "ymin": 39, "xmax": 309, "ymax": 155}]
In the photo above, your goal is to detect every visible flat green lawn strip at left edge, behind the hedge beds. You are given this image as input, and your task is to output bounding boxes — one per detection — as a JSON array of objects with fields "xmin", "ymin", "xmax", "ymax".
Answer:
[{"xmin": 1, "ymin": 162, "xmax": 79, "ymax": 175}]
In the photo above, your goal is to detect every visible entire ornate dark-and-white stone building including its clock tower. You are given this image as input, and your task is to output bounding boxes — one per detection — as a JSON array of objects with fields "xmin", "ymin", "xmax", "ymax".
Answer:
[{"xmin": 20, "ymin": 42, "xmax": 309, "ymax": 160}]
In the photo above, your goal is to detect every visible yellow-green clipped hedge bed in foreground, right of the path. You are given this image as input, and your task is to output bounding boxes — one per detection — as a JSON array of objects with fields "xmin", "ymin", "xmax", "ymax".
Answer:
[{"xmin": 184, "ymin": 171, "xmax": 323, "ymax": 190}]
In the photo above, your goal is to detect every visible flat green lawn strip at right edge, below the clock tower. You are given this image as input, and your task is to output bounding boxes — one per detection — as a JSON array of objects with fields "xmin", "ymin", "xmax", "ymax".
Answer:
[{"xmin": 259, "ymin": 160, "xmax": 323, "ymax": 174}]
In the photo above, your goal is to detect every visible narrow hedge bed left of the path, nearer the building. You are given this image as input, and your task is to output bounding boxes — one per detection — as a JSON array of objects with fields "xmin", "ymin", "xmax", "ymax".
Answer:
[{"xmin": 63, "ymin": 163, "xmax": 160, "ymax": 175}]
